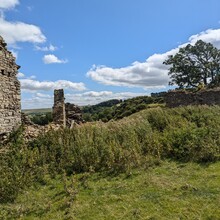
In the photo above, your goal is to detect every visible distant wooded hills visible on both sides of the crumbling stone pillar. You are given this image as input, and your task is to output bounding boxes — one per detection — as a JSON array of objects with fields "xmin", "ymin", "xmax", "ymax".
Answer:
[{"xmin": 22, "ymin": 93, "xmax": 164, "ymax": 125}]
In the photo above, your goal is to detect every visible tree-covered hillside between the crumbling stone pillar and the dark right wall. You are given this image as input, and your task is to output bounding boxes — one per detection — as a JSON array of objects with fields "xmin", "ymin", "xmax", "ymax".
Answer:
[{"xmin": 82, "ymin": 96, "xmax": 164, "ymax": 122}]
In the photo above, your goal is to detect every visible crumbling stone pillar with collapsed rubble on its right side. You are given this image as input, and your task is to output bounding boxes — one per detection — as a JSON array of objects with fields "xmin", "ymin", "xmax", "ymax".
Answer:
[{"xmin": 53, "ymin": 89, "xmax": 84, "ymax": 128}]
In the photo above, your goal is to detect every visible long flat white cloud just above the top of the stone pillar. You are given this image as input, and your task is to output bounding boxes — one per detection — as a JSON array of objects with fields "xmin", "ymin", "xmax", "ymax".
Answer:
[{"xmin": 20, "ymin": 78, "xmax": 86, "ymax": 91}]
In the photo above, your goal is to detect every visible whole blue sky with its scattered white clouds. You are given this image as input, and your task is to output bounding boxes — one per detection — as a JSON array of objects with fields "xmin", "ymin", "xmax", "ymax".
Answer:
[{"xmin": 0, "ymin": 0, "xmax": 220, "ymax": 108}]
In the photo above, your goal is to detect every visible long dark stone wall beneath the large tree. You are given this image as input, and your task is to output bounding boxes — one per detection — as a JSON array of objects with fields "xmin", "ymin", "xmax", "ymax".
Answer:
[{"xmin": 165, "ymin": 88, "xmax": 220, "ymax": 107}]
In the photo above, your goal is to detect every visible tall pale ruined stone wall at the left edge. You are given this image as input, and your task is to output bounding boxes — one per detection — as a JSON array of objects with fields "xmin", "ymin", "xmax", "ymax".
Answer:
[{"xmin": 0, "ymin": 36, "xmax": 21, "ymax": 136}]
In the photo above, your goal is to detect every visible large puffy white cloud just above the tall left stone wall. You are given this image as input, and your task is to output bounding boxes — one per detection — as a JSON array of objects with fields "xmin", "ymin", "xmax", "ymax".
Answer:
[{"xmin": 0, "ymin": 17, "xmax": 46, "ymax": 45}]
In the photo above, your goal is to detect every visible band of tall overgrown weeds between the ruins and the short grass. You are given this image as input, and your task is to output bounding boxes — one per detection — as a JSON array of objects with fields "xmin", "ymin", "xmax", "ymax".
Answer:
[{"xmin": 0, "ymin": 106, "xmax": 220, "ymax": 219}]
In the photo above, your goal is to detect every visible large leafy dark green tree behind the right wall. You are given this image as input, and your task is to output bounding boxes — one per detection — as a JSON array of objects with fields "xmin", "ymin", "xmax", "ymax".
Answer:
[{"xmin": 163, "ymin": 40, "xmax": 220, "ymax": 88}]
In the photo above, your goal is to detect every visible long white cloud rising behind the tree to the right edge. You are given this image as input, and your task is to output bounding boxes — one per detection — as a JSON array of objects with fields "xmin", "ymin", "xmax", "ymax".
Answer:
[{"xmin": 87, "ymin": 29, "xmax": 220, "ymax": 89}]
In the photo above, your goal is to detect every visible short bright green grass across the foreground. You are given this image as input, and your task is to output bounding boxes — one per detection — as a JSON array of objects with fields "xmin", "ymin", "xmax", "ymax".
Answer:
[{"xmin": 0, "ymin": 161, "xmax": 220, "ymax": 220}]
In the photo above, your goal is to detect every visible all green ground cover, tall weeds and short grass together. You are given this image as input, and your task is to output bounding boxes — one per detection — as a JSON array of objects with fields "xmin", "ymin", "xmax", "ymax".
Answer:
[{"xmin": 0, "ymin": 106, "xmax": 220, "ymax": 220}]
